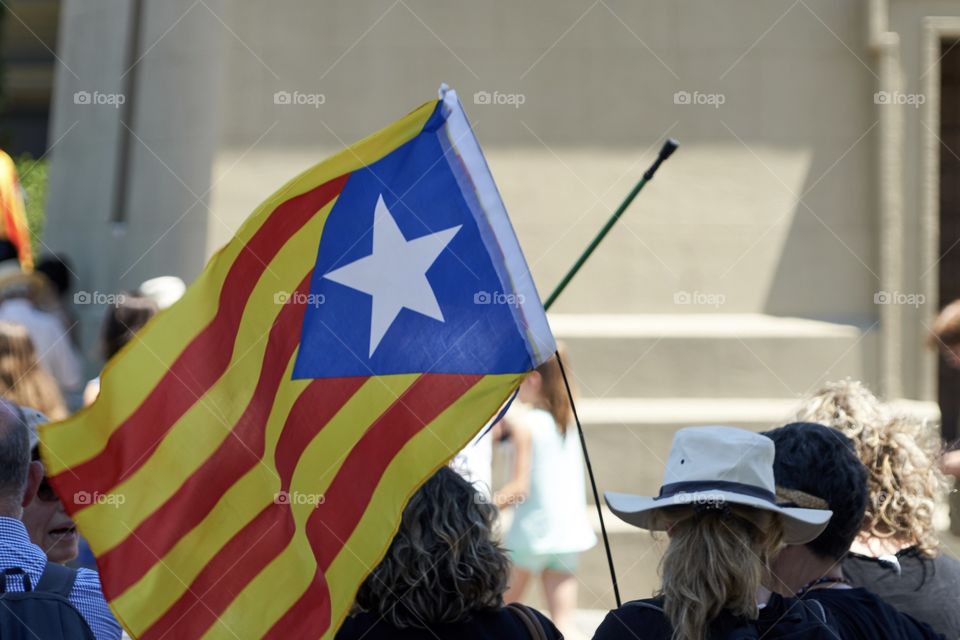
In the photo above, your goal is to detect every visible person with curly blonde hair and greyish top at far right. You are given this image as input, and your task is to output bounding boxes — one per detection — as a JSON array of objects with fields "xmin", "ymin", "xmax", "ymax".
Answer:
[{"xmin": 797, "ymin": 380, "xmax": 960, "ymax": 638}]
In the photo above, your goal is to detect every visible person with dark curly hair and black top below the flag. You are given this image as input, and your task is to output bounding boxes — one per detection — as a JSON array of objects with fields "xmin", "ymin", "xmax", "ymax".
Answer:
[{"xmin": 336, "ymin": 467, "xmax": 563, "ymax": 640}]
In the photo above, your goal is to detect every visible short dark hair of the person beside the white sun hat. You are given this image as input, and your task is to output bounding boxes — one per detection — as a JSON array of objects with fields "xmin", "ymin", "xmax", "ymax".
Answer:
[{"xmin": 763, "ymin": 422, "xmax": 867, "ymax": 560}]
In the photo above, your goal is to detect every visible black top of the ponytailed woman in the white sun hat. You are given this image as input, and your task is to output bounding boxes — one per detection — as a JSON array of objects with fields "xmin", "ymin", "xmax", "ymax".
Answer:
[{"xmin": 593, "ymin": 594, "xmax": 837, "ymax": 640}]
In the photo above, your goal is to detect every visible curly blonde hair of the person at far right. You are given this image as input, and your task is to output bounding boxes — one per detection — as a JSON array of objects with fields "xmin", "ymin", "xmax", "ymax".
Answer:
[{"xmin": 797, "ymin": 380, "xmax": 948, "ymax": 558}]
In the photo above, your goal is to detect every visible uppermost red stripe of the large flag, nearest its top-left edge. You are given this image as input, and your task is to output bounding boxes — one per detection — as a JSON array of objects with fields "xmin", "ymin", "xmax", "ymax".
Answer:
[{"xmin": 52, "ymin": 174, "xmax": 349, "ymax": 502}]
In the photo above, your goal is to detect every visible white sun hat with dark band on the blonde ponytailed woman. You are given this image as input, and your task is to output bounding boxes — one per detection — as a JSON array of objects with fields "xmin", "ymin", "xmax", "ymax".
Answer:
[{"xmin": 604, "ymin": 427, "xmax": 833, "ymax": 544}]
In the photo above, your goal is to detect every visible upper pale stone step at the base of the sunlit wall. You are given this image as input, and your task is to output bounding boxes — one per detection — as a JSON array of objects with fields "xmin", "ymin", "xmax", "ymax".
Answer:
[{"xmin": 550, "ymin": 313, "xmax": 877, "ymax": 398}]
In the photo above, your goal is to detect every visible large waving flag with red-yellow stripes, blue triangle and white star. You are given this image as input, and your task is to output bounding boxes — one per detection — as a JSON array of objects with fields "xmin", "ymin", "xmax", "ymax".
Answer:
[{"xmin": 41, "ymin": 89, "xmax": 555, "ymax": 640}]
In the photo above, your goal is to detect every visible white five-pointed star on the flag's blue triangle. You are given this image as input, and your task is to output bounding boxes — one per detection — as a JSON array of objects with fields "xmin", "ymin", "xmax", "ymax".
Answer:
[{"xmin": 324, "ymin": 195, "xmax": 461, "ymax": 357}]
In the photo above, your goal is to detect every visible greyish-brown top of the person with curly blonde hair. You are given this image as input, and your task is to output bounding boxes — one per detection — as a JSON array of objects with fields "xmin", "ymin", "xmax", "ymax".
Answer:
[{"xmin": 843, "ymin": 547, "xmax": 960, "ymax": 640}]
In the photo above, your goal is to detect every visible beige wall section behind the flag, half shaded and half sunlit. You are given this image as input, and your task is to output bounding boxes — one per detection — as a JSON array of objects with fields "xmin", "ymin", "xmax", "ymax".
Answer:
[{"xmin": 208, "ymin": 0, "xmax": 877, "ymax": 324}]
